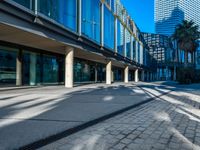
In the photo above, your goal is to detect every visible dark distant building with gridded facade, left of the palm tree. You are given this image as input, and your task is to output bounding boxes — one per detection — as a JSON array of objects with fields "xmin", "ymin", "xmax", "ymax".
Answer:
[{"xmin": 143, "ymin": 33, "xmax": 176, "ymax": 80}]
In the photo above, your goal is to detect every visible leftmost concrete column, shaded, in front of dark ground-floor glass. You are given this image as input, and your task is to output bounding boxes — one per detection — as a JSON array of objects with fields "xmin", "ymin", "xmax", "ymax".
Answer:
[{"xmin": 16, "ymin": 50, "xmax": 22, "ymax": 86}]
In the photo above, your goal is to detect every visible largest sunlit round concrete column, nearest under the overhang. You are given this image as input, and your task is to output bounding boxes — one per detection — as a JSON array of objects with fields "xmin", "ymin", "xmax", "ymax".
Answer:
[{"xmin": 65, "ymin": 47, "xmax": 74, "ymax": 88}]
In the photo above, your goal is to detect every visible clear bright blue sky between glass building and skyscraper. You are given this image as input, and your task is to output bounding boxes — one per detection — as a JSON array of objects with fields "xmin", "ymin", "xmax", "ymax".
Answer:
[{"xmin": 121, "ymin": 0, "xmax": 154, "ymax": 33}]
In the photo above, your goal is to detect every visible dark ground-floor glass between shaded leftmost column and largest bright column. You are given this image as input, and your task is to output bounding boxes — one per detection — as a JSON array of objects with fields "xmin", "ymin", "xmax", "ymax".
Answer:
[{"xmin": 22, "ymin": 51, "xmax": 64, "ymax": 85}]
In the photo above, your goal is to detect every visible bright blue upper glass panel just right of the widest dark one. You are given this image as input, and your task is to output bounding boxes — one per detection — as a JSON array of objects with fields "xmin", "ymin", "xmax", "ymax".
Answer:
[{"xmin": 81, "ymin": 0, "xmax": 100, "ymax": 43}]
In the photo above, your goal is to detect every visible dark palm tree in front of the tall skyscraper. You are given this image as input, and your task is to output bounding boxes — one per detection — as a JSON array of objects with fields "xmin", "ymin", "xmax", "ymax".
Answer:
[{"xmin": 172, "ymin": 20, "xmax": 200, "ymax": 66}]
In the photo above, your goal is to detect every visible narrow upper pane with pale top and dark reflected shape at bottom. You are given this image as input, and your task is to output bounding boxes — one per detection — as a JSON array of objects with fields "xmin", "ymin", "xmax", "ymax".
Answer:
[{"xmin": 117, "ymin": 20, "xmax": 124, "ymax": 55}]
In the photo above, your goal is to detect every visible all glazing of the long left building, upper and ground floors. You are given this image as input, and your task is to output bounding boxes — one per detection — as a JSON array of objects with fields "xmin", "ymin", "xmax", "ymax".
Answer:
[{"xmin": 0, "ymin": 0, "xmax": 153, "ymax": 85}]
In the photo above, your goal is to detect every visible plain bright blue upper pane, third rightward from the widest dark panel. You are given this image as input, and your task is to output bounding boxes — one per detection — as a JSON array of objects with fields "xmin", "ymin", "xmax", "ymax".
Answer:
[{"xmin": 104, "ymin": 6, "xmax": 114, "ymax": 50}]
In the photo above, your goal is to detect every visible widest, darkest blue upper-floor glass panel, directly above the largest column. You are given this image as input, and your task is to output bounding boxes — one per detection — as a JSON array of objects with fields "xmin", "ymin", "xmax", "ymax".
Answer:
[{"xmin": 38, "ymin": 0, "xmax": 77, "ymax": 31}]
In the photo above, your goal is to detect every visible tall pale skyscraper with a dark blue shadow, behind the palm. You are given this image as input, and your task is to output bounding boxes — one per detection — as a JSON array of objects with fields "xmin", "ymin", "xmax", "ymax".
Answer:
[{"xmin": 154, "ymin": 0, "xmax": 200, "ymax": 35}]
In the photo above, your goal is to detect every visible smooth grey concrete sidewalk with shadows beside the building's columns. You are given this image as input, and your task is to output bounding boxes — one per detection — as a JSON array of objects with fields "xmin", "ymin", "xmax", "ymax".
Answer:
[{"xmin": 0, "ymin": 83, "xmax": 171, "ymax": 149}]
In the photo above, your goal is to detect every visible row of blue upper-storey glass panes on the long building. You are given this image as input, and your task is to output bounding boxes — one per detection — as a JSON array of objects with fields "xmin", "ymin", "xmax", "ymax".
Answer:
[{"xmin": 10, "ymin": 0, "xmax": 145, "ymax": 59}]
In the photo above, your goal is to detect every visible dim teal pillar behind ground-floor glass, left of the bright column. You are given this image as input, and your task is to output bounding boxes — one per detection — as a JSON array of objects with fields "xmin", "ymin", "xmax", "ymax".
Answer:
[{"xmin": 29, "ymin": 53, "xmax": 37, "ymax": 85}]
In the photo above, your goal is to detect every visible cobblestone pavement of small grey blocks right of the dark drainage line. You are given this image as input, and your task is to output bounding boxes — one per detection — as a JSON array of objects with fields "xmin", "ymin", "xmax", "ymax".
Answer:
[{"xmin": 40, "ymin": 85, "xmax": 200, "ymax": 150}]
